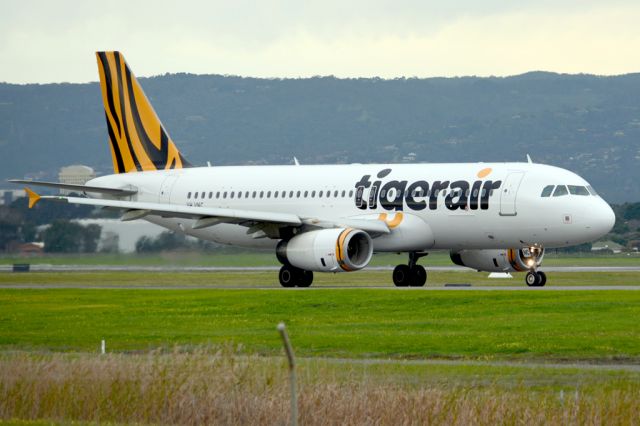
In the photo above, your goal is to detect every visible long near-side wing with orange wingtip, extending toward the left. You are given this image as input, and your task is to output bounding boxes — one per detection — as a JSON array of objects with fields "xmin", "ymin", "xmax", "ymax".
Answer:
[{"xmin": 25, "ymin": 188, "xmax": 389, "ymax": 233}]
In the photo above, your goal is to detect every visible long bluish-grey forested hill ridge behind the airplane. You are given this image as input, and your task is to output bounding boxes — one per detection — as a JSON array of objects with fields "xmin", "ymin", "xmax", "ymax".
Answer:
[{"xmin": 0, "ymin": 72, "xmax": 640, "ymax": 203}]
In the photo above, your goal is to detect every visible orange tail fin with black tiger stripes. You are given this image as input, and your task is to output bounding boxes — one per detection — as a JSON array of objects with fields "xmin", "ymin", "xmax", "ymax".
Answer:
[{"xmin": 96, "ymin": 52, "xmax": 191, "ymax": 173}]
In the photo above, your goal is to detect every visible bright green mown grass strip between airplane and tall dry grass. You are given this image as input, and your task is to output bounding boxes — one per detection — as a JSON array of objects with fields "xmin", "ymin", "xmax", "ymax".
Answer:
[{"xmin": 0, "ymin": 282, "xmax": 640, "ymax": 362}]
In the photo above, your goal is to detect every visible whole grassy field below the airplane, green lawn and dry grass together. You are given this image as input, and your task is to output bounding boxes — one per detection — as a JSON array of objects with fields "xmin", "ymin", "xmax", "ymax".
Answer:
[{"xmin": 0, "ymin": 272, "xmax": 640, "ymax": 426}]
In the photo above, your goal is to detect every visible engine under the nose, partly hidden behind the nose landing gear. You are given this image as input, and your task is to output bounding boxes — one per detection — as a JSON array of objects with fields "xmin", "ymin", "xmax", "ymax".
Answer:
[{"xmin": 450, "ymin": 247, "xmax": 544, "ymax": 272}]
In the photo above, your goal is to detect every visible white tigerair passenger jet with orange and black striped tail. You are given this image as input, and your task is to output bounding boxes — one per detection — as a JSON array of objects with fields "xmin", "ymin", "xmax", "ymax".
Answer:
[{"xmin": 13, "ymin": 52, "xmax": 615, "ymax": 287}]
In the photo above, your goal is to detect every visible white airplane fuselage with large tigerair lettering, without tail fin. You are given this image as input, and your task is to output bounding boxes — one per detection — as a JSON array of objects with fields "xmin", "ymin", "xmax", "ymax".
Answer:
[{"xmin": 87, "ymin": 163, "xmax": 614, "ymax": 252}]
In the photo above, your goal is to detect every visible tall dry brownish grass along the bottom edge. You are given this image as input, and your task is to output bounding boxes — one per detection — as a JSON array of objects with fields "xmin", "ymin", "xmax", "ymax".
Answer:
[{"xmin": 0, "ymin": 348, "xmax": 640, "ymax": 425}]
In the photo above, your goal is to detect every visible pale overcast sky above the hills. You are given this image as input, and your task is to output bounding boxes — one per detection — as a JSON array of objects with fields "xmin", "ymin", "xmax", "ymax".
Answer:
[{"xmin": 0, "ymin": 0, "xmax": 640, "ymax": 83}]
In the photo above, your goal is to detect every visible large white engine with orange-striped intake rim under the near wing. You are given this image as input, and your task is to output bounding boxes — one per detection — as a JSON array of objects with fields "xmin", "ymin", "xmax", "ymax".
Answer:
[{"xmin": 276, "ymin": 228, "xmax": 373, "ymax": 272}]
